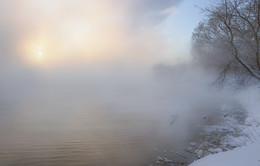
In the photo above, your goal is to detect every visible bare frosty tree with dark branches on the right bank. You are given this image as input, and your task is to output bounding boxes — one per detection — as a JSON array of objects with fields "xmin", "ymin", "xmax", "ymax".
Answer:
[{"xmin": 192, "ymin": 0, "xmax": 260, "ymax": 81}]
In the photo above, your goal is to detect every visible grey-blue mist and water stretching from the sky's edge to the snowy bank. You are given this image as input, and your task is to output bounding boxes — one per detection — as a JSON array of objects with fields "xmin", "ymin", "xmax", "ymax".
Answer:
[{"xmin": 0, "ymin": 63, "xmax": 241, "ymax": 166}]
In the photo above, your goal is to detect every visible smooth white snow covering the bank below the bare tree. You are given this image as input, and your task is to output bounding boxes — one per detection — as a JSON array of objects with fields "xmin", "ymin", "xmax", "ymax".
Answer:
[{"xmin": 189, "ymin": 87, "xmax": 260, "ymax": 166}]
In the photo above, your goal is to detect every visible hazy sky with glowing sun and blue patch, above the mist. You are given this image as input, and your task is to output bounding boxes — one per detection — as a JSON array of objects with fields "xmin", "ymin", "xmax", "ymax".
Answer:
[{"xmin": 0, "ymin": 0, "xmax": 210, "ymax": 67}]
